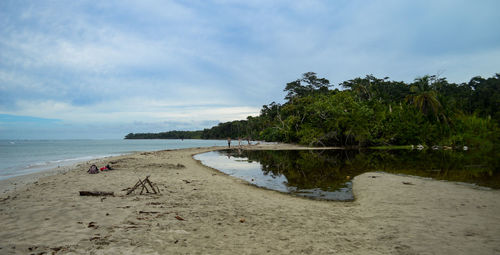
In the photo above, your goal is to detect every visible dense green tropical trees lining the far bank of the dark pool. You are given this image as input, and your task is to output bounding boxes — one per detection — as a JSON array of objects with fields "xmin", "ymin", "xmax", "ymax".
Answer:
[{"xmin": 129, "ymin": 72, "xmax": 500, "ymax": 148}]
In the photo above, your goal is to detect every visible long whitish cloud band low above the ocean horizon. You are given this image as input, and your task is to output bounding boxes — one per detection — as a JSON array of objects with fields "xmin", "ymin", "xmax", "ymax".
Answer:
[{"xmin": 6, "ymin": 98, "xmax": 260, "ymax": 123}]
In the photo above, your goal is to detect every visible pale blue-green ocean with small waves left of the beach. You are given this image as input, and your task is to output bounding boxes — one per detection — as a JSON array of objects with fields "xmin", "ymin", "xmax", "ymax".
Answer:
[{"xmin": 0, "ymin": 139, "xmax": 227, "ymax": 180}]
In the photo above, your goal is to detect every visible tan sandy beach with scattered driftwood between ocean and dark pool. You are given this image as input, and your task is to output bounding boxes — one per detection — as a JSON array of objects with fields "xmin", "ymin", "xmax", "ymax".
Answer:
[{"xmin": 0, "ymin": 144, "xmax": 500, "ymax": 255}]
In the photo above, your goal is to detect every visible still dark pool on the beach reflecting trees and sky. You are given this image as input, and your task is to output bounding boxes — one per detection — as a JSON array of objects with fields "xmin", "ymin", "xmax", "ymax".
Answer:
[{"xmin": 195, "ymin": 150, "xmax": 500, "ymax": 201}]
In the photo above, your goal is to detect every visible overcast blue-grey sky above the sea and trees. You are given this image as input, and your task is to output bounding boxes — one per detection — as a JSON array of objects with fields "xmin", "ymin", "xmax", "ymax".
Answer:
[{"xmin": 0, "ymin": 0, "xmax": 500, "ymax": 139}]
